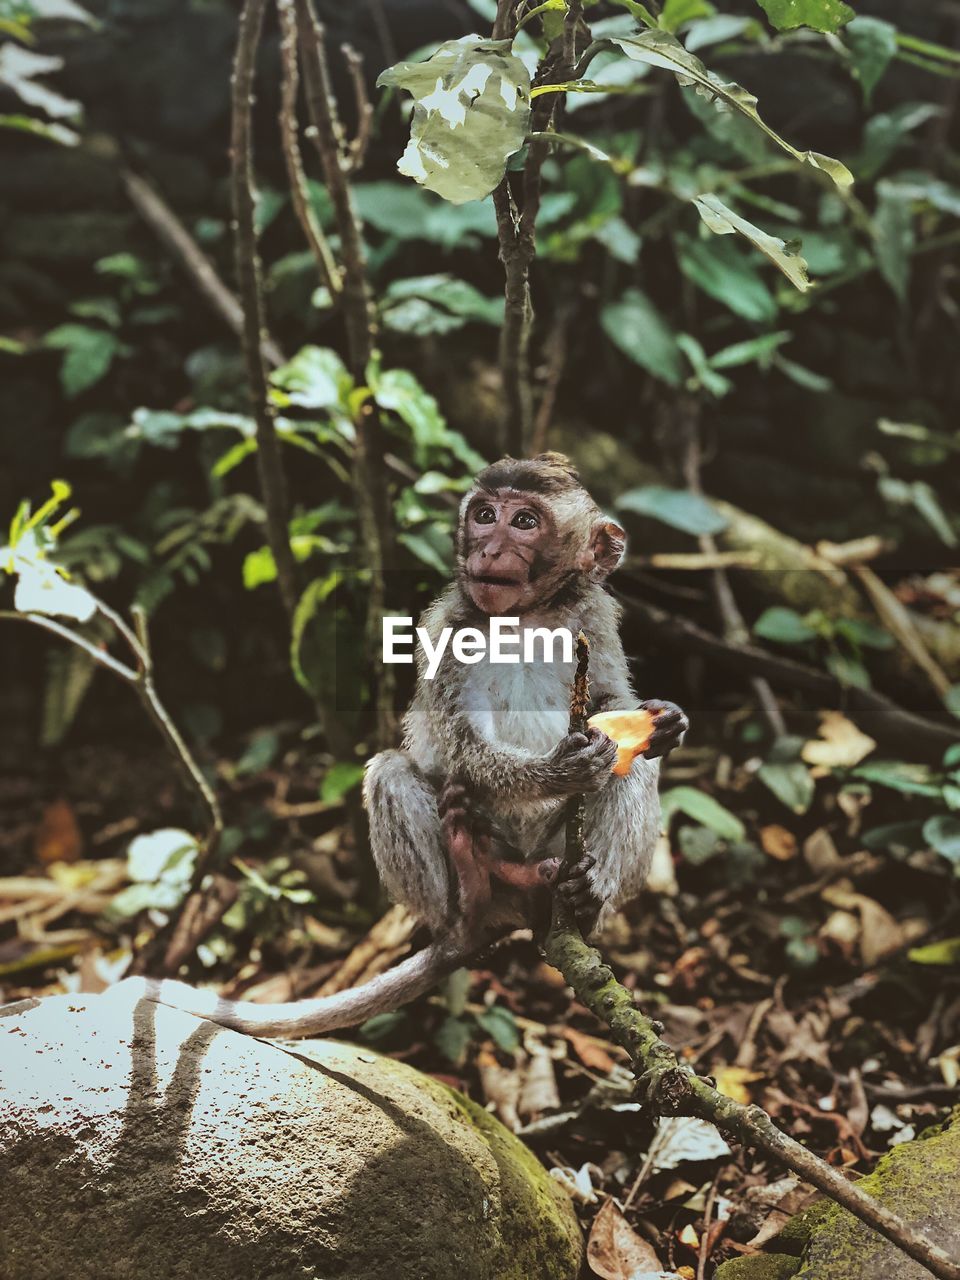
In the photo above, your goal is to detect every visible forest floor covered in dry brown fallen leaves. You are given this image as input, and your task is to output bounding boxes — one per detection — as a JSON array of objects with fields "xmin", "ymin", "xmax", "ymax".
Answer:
[{"xmin": 0, "ymin": 717, "xmax": 960, "ymax": 1280}]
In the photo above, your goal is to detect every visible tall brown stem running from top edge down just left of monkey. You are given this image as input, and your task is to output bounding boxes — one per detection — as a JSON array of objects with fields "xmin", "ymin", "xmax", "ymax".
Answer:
[{"xmin": 295, "ymin": 0, "xmax": 397, "ymax": 748}]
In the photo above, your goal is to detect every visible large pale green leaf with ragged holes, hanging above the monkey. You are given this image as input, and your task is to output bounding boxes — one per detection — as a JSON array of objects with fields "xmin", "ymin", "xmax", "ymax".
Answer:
[{"xmin": 376, "ymin": 36, "xmax": 530, "ymax": 205}]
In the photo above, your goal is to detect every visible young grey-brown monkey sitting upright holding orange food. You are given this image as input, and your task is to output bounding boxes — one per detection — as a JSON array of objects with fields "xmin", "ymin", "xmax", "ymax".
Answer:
[{"xmin": 115, "ymin": 453, "xmax": 687, "ymax": 1037}]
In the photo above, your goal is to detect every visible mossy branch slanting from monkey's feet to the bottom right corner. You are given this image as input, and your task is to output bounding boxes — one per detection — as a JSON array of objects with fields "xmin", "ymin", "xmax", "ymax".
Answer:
[{"xmin": 545, "ymin": 928, "xmax": 960, "ymax": 1280}]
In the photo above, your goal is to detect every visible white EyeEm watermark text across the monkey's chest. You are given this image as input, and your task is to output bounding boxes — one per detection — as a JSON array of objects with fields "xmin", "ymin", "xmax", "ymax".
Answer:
[{"xmin": 383, "ymin": 617, "xmax": 575, "ymax": 680}]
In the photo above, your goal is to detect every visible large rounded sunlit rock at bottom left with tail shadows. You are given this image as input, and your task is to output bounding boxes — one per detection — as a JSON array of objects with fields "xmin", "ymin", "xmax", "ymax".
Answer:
[{"xmin": 0, "ymin": 995, "xmax": 581, "ymax": 1280}]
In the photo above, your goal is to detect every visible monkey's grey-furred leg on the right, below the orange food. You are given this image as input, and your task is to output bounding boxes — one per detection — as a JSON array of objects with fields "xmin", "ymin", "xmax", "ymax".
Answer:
[{"xmin": 558, "ymin": 759, "xmax": 660, "ymax": 933}]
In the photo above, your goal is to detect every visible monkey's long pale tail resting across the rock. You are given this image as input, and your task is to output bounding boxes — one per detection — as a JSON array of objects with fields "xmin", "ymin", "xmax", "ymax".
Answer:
[{"xmin": 114, "ymin": 936, "xmax": 475, "ymax": 1039}]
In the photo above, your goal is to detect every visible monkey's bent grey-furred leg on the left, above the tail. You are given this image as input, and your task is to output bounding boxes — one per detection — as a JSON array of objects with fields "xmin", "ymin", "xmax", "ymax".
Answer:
[{"xmin": 364, "ymin": 751, "xmax": 451, "ymax": 934}]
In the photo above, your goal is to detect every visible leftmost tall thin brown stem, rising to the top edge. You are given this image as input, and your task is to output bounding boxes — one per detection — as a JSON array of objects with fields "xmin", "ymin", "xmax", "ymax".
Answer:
[{"xmin": 230, "ymin": 0, "xmax": 300, "ymax": 618}]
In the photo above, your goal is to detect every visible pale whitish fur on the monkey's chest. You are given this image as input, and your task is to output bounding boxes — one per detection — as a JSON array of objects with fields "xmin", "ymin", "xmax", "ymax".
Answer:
[{"xmin": 463, "ymin": 662, "xmax": 575, "ymax": 755}]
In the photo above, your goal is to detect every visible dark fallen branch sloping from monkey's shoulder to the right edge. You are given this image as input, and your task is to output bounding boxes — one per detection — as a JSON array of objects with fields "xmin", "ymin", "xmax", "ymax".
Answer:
[{"xmin": 620, "ymin": 589, "xmax": 956, "ymax": 763}]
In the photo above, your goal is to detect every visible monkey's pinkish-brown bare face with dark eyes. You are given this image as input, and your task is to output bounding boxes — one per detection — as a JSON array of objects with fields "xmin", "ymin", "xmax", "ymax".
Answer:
[{"xmin": 462, "ymin": 493, "xmax": 556, "ymax": 617}]
